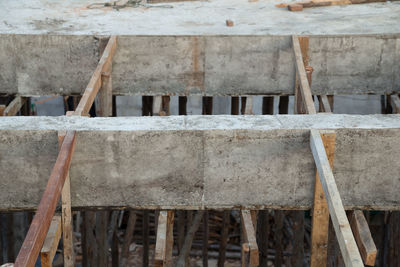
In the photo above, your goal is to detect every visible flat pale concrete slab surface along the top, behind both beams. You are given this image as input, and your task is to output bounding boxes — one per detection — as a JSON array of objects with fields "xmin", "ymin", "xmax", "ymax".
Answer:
[{"xmin": 0, "ymin": 0, "xmax": 400, "ymax": 35}]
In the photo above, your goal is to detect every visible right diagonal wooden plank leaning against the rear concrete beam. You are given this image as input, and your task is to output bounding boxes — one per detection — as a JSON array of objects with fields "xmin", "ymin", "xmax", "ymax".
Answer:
[{"xmin": 292, "ymin": 35, "xmax": 316, "ymax": 114}]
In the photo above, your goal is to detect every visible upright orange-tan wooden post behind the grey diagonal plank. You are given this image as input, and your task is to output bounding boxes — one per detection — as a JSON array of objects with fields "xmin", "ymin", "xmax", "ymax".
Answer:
[{"xmin": 310, "ymin": 132, "xmax": 336, "ymax": 267}]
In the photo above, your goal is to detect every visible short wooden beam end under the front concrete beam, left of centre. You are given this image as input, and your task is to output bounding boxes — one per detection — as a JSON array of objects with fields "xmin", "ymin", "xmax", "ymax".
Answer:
[{"xmin": 154, "ymin": 211, "xmax": 174, "ymax": 266}]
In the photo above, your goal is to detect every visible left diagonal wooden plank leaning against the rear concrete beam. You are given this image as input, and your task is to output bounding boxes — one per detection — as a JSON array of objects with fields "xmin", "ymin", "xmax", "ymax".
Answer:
[{"xmin": 74, "ymin": 36, "xmax": 117, "ymax": 116}]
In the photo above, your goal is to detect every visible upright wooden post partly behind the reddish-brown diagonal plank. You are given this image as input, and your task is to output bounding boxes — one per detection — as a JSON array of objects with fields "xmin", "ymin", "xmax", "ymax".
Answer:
[{"xmin": 58, "ymin": 132, "xmax": 75, "ymax": 267}]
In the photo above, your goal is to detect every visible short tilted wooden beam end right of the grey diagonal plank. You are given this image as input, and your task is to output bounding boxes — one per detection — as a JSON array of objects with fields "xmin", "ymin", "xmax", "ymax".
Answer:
[{"xmin": 350, "ymin": 210, "xmax": 377, "ymax": 266}]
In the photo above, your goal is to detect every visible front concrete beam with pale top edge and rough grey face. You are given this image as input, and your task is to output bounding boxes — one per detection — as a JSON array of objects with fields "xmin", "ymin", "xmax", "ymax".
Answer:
[{"xmin": 0, "ymin": 115, "xmax": 400, "ymax": 209}]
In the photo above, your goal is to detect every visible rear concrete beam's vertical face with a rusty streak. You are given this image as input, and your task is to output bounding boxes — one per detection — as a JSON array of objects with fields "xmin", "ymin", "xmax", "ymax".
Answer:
[{"xmin": 0, "ymin": 34, "xmax": 400, "ymax": 96}]
